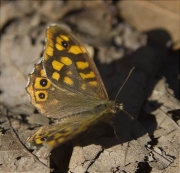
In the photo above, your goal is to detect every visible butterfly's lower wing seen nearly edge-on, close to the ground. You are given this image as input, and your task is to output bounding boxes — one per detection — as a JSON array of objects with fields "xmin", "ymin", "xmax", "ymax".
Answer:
[{"xmin": 29, "ymin": 104, "xmax": 109, "ymax": 148}]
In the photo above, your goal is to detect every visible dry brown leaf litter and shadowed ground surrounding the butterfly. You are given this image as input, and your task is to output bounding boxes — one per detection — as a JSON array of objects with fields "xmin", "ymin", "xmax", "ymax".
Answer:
[{"xmin": 0, "ymin": 0, "xmax": 180, "ymax": 173}]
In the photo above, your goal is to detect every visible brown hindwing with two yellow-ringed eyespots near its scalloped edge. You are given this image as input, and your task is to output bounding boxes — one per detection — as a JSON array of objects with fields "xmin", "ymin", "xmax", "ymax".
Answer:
[{"xmin": 27, "ymin": 61, "xmax": 107, "ymax": 118}]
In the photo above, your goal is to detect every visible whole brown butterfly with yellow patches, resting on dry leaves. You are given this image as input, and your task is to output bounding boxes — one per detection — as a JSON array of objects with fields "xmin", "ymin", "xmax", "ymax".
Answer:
[{"xmin": 26, "ymin": 25, "xmax": 122, "ymax": 148}]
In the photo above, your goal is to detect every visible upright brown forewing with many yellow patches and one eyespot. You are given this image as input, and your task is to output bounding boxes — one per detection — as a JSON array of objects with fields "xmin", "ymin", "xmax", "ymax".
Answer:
[{"xmin": 44, "ymin": 25, "xmax": 108, "ymax": 99}]
